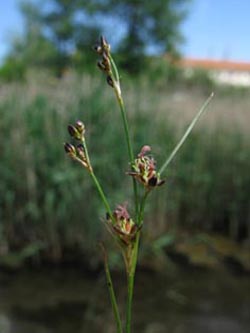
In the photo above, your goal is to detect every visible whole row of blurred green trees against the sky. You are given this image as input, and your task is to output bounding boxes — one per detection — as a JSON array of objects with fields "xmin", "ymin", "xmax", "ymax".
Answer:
[{"xmin": 0, "ymin": 0, "xmax": 189, "ymax": 73}]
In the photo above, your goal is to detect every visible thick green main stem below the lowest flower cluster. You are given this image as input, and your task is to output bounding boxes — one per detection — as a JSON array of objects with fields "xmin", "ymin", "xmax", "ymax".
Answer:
[{"xmin": 126, "ymin": 231, "xmax": 140, "ymax": 333}]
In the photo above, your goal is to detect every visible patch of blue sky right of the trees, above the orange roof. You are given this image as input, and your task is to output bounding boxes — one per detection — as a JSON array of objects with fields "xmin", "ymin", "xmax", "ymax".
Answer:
[{"xmin": 182, "ymin": 0, "xmax": 250, "ymax": 62}]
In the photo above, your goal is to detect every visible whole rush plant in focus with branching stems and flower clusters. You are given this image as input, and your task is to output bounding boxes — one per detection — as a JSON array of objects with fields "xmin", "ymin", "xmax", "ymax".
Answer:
[{"xmin": 64, "ymin": 37, "xmax": 213, "ymax": 333}]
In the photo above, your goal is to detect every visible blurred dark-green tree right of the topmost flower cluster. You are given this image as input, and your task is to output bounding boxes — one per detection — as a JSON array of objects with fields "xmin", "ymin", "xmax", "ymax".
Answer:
[{"xmin": 90, "ymin": 0, "xmax": 189, "ymax": 71}]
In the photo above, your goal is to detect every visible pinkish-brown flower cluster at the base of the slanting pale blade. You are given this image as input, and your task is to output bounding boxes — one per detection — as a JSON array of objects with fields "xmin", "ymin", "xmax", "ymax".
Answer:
[{"xmin": 128, "ymin": 146, "xmax": 165, "ymax": 190}]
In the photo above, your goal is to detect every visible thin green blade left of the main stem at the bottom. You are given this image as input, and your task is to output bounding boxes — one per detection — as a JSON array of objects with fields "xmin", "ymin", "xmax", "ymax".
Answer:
[{"xmin": 101, "ymin": 244, "xmax": 123, "ymax": 333}]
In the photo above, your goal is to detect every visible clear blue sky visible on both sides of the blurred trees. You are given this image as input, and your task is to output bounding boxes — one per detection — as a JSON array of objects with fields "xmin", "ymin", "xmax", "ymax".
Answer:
[{"xmin": 0, "ymin": 0, "xmax": 250, "ymax": 62}]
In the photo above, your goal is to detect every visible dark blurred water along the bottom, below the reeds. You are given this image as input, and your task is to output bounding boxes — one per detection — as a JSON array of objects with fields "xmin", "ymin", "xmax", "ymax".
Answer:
[{"xmin": 0, "ymin": 269, "xmax": 250, "ymax": 333}]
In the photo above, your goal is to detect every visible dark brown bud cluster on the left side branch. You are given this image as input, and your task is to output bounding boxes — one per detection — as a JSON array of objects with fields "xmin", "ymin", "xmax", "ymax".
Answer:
[{"xmin": 64, "ymin": 120, "xmax": 92, "ymax": 172}]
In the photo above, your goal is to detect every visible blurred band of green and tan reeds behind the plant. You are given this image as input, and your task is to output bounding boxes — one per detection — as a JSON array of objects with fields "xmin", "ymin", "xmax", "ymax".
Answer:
[{"xmin": 0, "ymin": 72, "xmax": 250, "ymax": 259}]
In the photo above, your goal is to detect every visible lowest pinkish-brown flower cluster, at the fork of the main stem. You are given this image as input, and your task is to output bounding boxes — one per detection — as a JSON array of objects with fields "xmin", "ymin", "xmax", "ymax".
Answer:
[{"xmin": 107, "ymin": 205, "xmax": 138, "ymax": 245}]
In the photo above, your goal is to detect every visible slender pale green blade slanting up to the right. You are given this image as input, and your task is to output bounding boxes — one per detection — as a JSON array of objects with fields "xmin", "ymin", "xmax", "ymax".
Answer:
[{"xmin": 159, "ymin": 93, "xmax": 214, "ymax": 174}]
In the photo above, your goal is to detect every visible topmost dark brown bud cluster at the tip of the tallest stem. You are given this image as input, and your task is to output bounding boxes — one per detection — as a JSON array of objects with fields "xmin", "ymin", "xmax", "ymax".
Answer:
[{"xmin": 94, "ymin": 36, "xmax": 114, "ymax": 88}]
